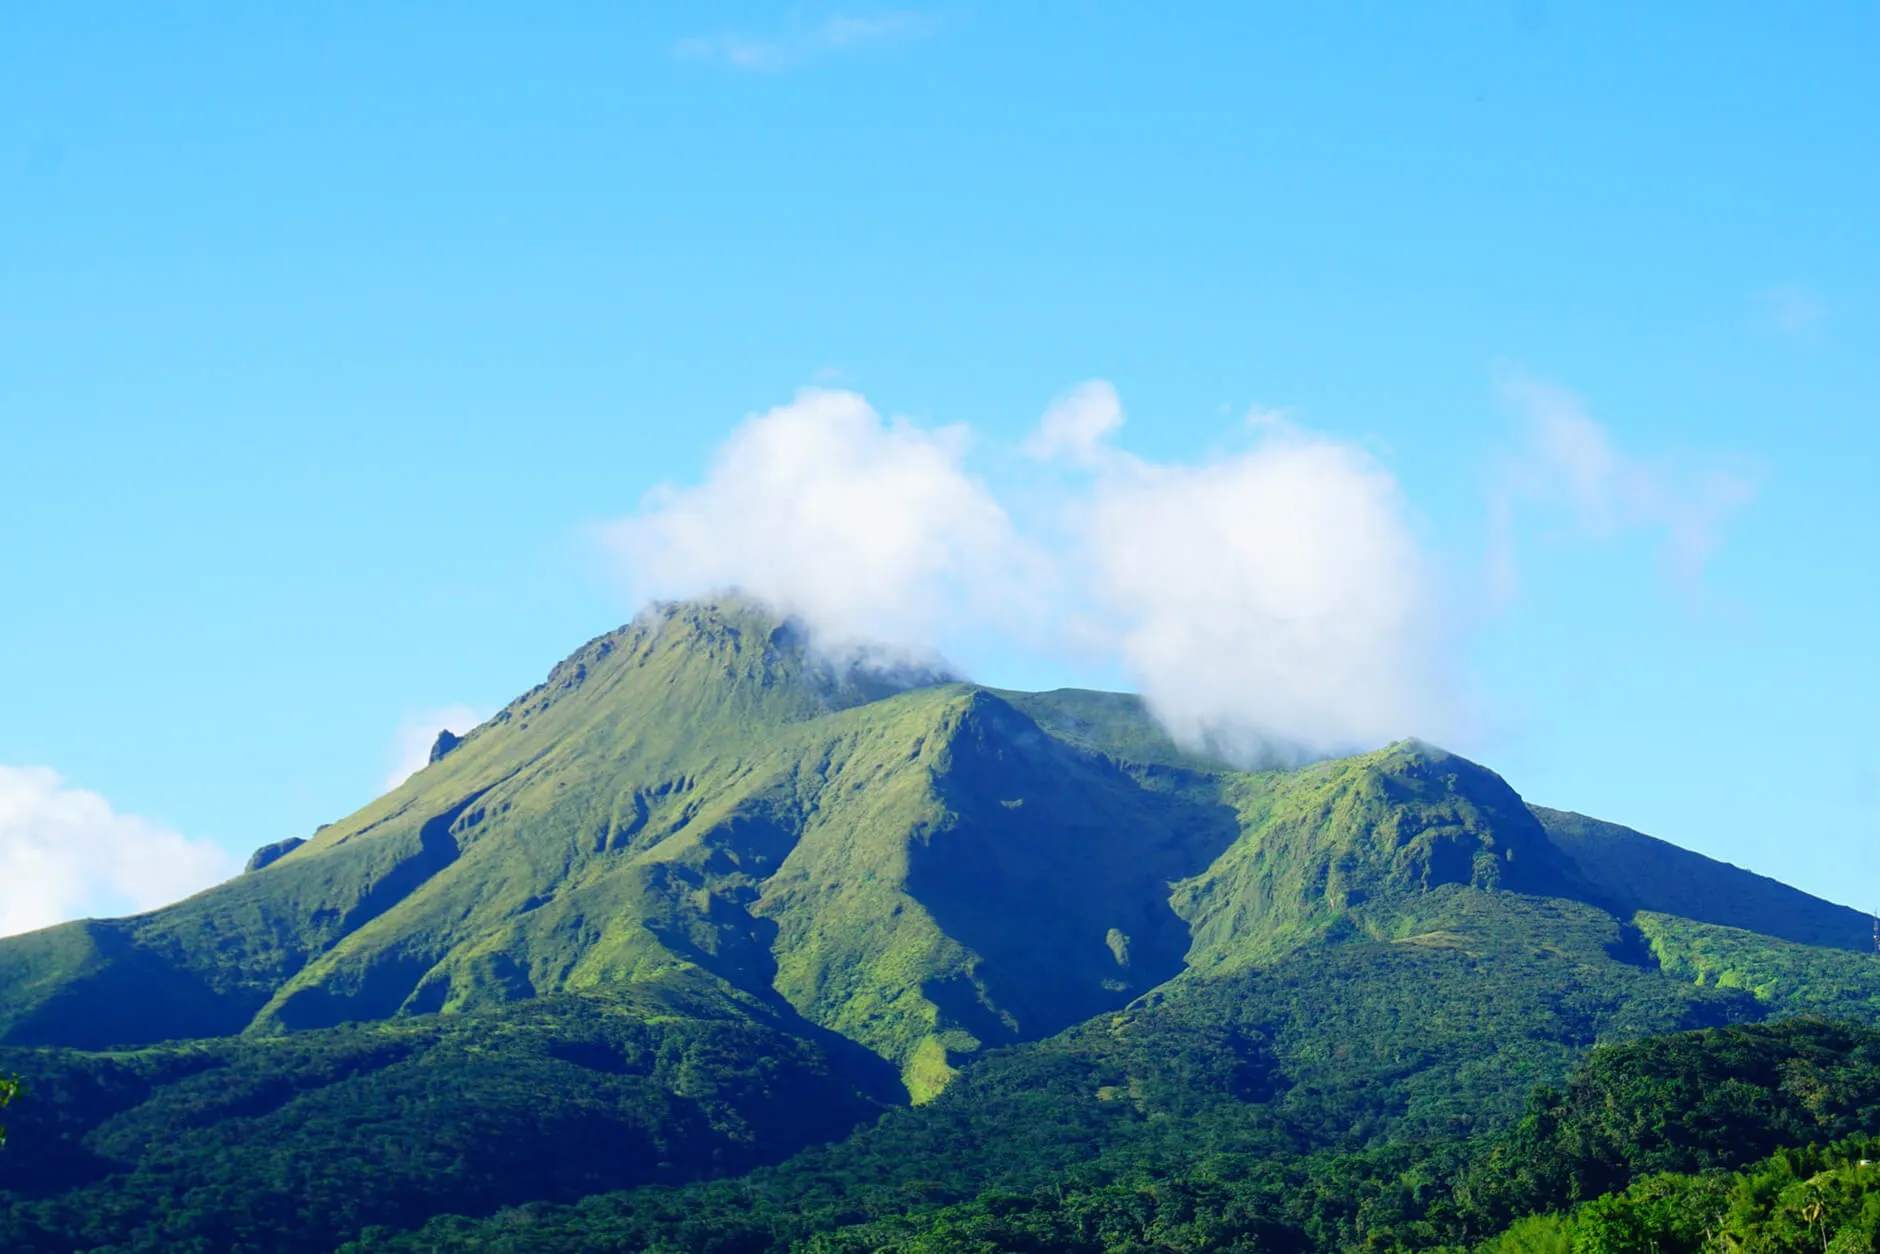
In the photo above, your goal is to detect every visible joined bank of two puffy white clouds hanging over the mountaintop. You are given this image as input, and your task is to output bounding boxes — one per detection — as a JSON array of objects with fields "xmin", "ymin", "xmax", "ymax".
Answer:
[{"xmin": 607, "ymin": 380, "xmax": 1453, "ymax": 761}]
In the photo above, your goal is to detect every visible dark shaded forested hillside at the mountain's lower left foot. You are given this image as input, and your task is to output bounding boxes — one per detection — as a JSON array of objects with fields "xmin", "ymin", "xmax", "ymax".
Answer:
[{"xmin": 0, "ymin": 981, "xmax": 899, "ymax": 1252}]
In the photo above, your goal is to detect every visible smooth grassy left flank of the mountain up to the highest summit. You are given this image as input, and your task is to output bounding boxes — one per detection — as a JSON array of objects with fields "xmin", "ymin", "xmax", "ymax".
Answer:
[{"xmin": 0, "ymin": 605, "xmax": 902, "ymax": 1045}]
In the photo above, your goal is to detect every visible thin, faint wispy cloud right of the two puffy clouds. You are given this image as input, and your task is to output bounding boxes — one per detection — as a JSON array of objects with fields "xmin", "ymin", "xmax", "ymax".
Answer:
[{"xmin": 1489, "ymin": 374, "xmax": 1756, "ymax": 600}]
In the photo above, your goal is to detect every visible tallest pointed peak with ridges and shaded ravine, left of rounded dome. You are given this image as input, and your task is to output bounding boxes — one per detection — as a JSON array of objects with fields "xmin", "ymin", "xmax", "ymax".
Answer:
[{"xmin": 0, "ymin": 603, "xmax": 1235, "ymax": 1092}]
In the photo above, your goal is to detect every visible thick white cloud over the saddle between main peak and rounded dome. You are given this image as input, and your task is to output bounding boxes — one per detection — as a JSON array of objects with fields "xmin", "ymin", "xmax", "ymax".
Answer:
[{"xmin": 1047, "ymin": 402, "xmax": 1453, "ymax": 761}]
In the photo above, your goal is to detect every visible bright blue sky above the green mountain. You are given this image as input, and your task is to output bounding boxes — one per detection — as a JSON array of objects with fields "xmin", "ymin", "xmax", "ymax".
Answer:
[{"xmin": 0, "ymin": 0, "xmax": 1880, "ymax": 931}]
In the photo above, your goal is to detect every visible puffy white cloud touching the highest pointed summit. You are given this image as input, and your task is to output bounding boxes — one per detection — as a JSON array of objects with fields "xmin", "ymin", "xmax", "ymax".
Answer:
[{"xmin": 605, "ymin": 391, "xmax": 1034, "ymax": 665}]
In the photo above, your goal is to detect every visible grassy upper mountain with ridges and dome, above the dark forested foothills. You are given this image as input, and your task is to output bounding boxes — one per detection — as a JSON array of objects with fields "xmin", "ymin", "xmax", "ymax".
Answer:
[{"xmin": 0, "ymin": 600, "xmax": 1867, "ymax": 1098}]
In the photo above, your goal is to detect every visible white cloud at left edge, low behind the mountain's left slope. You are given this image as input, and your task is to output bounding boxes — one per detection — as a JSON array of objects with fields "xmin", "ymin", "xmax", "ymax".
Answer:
[{"xmin": 0, "ymin": 765, "xmax": 237, "ymax": 936}]
